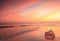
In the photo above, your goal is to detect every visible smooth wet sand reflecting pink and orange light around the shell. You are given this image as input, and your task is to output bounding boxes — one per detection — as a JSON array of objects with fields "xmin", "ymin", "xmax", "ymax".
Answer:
[{"xmin": 0, "ymin": 26, "xmax": 60, "ymax": 41}]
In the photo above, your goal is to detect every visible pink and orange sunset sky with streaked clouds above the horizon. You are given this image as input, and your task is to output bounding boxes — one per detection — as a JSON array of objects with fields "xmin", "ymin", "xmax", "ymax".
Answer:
[{"xmin": 0, "ymin": 0, "xmax": 60, "ymax": 23}]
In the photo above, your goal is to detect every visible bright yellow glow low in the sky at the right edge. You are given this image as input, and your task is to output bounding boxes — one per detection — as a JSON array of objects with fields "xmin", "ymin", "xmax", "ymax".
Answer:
[{"xmin": 42, "ymin": 10, "xmax": 60, "ymax": 21}]
